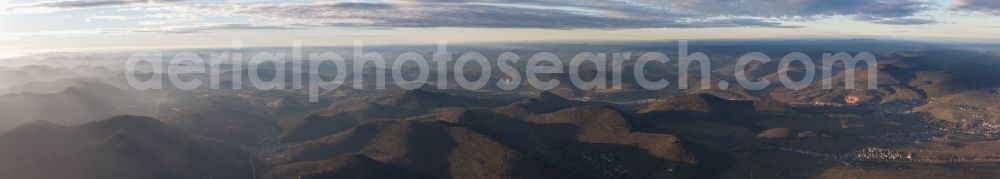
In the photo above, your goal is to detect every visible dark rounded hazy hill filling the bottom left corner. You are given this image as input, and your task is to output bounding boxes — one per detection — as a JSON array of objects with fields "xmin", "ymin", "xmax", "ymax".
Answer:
[{"xmin": 0, "ymin": 116, "xmax": 252, "ymax": 179}]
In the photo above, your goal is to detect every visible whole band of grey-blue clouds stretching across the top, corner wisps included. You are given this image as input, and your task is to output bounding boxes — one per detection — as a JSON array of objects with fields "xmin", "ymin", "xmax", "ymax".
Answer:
[{"xmin": 10, "ymin": 0, "xmax": 1000, "ymax": 32}]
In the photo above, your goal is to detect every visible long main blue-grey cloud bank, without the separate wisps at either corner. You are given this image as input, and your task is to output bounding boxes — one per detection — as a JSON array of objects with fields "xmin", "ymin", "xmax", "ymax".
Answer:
[{"xmin": 207, "ymin": 0, "xmax": 934, "ymax": 29}]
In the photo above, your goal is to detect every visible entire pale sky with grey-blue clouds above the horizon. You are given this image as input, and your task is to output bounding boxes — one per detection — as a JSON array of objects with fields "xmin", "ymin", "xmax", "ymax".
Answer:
[{"xmin": 0, "ymin": 0, "xmax": 1000, "ymax": 54}]
